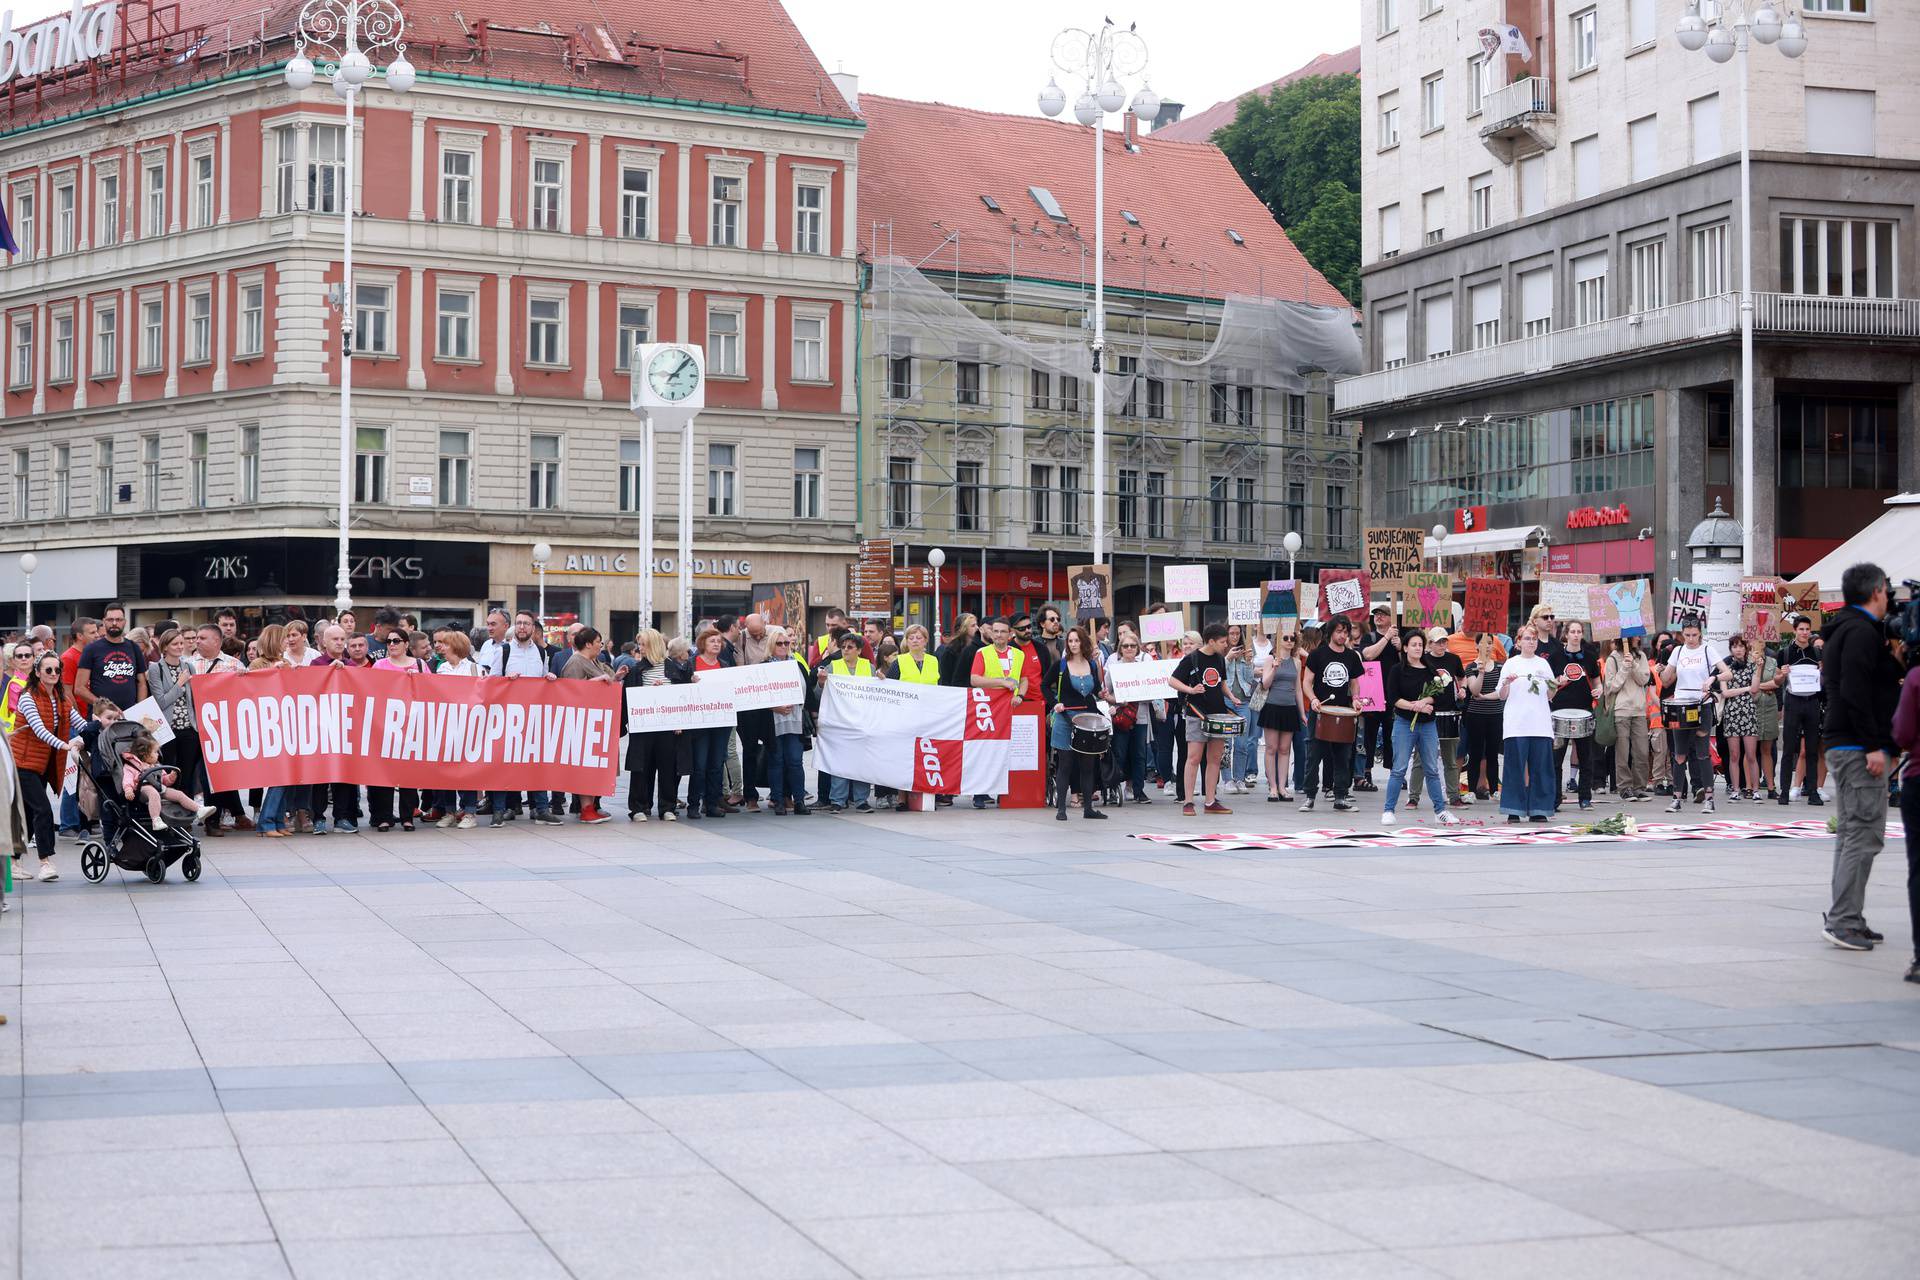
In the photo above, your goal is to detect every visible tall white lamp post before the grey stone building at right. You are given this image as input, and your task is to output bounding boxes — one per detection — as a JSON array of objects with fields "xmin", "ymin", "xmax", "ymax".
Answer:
[{"xmin": 1674, "ymin": 0, "xmax": 1807, "ymax": 574}]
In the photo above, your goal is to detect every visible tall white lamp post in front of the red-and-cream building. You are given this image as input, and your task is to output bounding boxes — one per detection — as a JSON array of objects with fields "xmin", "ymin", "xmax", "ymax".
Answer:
[{"xmin": 286, "ymin": 0, "xmax": 415, "ymax": 612}]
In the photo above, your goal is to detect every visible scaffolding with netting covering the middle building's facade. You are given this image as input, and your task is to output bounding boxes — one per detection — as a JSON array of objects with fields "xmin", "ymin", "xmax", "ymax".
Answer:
[{"xmin": 862, "ymin": 225, "xmax": 1361, "ymax": 587}]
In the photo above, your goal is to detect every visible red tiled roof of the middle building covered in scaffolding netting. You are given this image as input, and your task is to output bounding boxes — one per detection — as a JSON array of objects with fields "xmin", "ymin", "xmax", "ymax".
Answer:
[{"xmin": 860, "ymin": 94, "xmax": 1348, "ymax": 307}]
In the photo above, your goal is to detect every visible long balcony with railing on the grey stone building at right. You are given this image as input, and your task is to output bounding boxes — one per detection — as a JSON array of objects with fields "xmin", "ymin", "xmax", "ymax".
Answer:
[{"xmin": 1332, "ymin": 294, "xmax": 1920, "ymax": 415}]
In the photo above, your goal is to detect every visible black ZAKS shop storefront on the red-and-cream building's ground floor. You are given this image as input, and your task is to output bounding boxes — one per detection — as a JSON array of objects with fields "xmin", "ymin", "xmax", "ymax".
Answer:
[{"xmin": 119, "ymin": 537, "xmax": 490, "ymax": 631}]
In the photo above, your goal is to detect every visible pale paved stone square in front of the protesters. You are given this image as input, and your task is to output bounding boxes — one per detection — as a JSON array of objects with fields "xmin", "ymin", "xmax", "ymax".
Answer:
[{"xmin": 0, "ymin": 796, "xmax": 1920, "ymax": 1280}]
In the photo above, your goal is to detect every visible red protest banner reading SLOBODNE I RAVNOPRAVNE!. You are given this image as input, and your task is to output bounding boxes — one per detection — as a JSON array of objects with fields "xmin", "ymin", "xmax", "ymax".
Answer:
[{"xmin": 192, "ymin": 666, "xmax": 620, "ymax": 796}]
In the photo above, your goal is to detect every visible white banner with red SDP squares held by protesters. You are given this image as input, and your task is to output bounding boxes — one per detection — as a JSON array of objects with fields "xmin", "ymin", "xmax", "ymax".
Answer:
[{"xmin": 814, "ymin": 676, "xmax": 1014, "ymax": 796}]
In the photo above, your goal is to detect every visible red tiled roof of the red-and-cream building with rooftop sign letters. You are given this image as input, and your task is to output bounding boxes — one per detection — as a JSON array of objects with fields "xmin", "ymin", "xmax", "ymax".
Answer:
[{"xmin": 0, "ymin": 0, "xmax": 856, "ymax": 129}]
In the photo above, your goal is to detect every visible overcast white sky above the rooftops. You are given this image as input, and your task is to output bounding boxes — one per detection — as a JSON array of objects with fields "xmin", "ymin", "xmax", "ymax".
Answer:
[{"xmin": 11, "ymin": 0, "xmax": 1361, "ymax": 115}]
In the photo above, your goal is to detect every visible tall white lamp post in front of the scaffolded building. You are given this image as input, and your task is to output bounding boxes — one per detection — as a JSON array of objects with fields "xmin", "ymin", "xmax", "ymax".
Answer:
[{"xmin": 1041, "ymin": 19, "xmax": 1160, "ymax": 564}]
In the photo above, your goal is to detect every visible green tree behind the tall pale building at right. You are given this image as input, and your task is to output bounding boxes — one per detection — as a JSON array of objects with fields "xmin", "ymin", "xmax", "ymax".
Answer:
[{"xmin": 1213, "ymin": 75, "xmax": 1359, "ymax": 303}]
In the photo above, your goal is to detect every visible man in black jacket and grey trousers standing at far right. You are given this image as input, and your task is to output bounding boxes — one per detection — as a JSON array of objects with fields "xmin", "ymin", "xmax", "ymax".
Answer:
[{"xmin": 1820, "ymin": 564, "xmax": 1901, "ymax": 952}]
